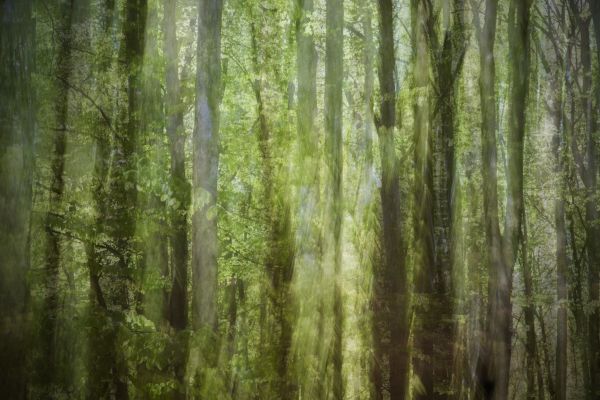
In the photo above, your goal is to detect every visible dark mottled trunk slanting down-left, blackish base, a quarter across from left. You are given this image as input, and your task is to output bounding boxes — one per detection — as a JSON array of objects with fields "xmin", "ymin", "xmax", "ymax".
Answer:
[{"xmin": 89, "ymin": 0, "xmax": 147, "ymax": 399}]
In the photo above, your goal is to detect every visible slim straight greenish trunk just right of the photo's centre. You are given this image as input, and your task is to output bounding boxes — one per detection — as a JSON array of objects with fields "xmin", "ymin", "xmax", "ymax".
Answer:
[{"xmin": 325, "ymin": 0, "xmax": 344, "ymax": 400}]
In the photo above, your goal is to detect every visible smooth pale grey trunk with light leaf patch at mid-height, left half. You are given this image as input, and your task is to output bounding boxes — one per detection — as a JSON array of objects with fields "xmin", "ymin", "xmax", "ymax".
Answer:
[{"xmin": 192, "ymin": 0, "xmax": 223, "ymax": 393}]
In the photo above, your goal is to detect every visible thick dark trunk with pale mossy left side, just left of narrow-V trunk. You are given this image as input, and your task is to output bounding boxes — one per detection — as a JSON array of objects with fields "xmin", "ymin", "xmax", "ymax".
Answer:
[{"xmin": 412, "ymin": 0, "xmax": 466, "ymax": 398}]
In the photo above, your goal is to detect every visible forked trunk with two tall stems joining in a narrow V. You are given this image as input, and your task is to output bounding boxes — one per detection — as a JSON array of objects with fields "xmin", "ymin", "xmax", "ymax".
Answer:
[{"xmin": 473, "ymin": 0, "xmax": 531, "ymax": 400}]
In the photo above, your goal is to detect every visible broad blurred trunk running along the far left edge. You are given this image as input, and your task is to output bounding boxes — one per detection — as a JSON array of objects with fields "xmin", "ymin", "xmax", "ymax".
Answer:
[{"xmin": 0, "ymin": 0, "xmax": 35, "ymax": 399}]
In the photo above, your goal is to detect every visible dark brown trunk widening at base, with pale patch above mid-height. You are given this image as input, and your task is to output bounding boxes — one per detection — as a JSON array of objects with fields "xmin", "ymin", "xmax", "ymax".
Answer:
[{"xmin": 372, "ymin": 0, "xmax": 409, "ymax": 400}]
